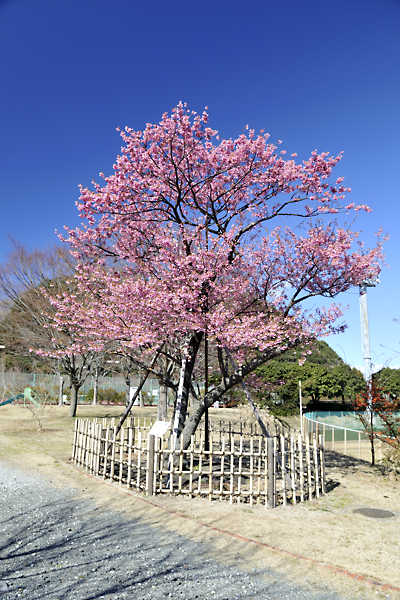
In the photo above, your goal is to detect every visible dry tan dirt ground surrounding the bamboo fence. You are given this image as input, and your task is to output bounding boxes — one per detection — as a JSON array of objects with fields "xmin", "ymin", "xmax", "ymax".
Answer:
[{"xmin": 0, "ymin": 405, "xmax": 400, "ymax": 598}]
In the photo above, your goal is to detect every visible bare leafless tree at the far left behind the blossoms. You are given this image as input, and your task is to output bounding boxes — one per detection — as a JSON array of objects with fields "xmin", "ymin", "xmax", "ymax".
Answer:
[{"xmin": 0, "ymin": 240, "xmax": 96, "ymax": 416}]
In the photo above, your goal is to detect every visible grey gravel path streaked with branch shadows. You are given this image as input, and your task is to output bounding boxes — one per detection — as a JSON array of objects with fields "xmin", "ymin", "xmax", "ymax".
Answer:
[{"xmin": 0, "ymin": 464, "xmax": 350, "ymax": 600}]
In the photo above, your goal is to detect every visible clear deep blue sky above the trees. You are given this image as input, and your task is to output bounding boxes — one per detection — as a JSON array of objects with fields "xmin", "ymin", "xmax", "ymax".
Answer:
[{"xmin": 0, "ymin": 0, "xmax": 400, "ymax": 366}]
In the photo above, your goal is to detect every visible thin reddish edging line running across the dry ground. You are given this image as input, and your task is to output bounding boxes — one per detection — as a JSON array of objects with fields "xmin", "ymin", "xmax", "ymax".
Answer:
[{"xmin": 69, "ymin": 465, "xmax": 400, "ymax": 592}]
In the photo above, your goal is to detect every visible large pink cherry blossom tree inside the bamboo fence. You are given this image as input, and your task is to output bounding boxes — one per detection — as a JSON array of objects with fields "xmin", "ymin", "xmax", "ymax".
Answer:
[{"xmin": 51, "ymin": 104, "xmax": 382, "ymax": 444}]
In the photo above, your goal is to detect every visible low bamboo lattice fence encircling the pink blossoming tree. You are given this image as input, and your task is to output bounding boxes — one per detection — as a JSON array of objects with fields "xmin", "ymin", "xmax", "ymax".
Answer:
[{"xmin": 72, "ymin": 417, "xmax": 325, "ymax": 508}]
